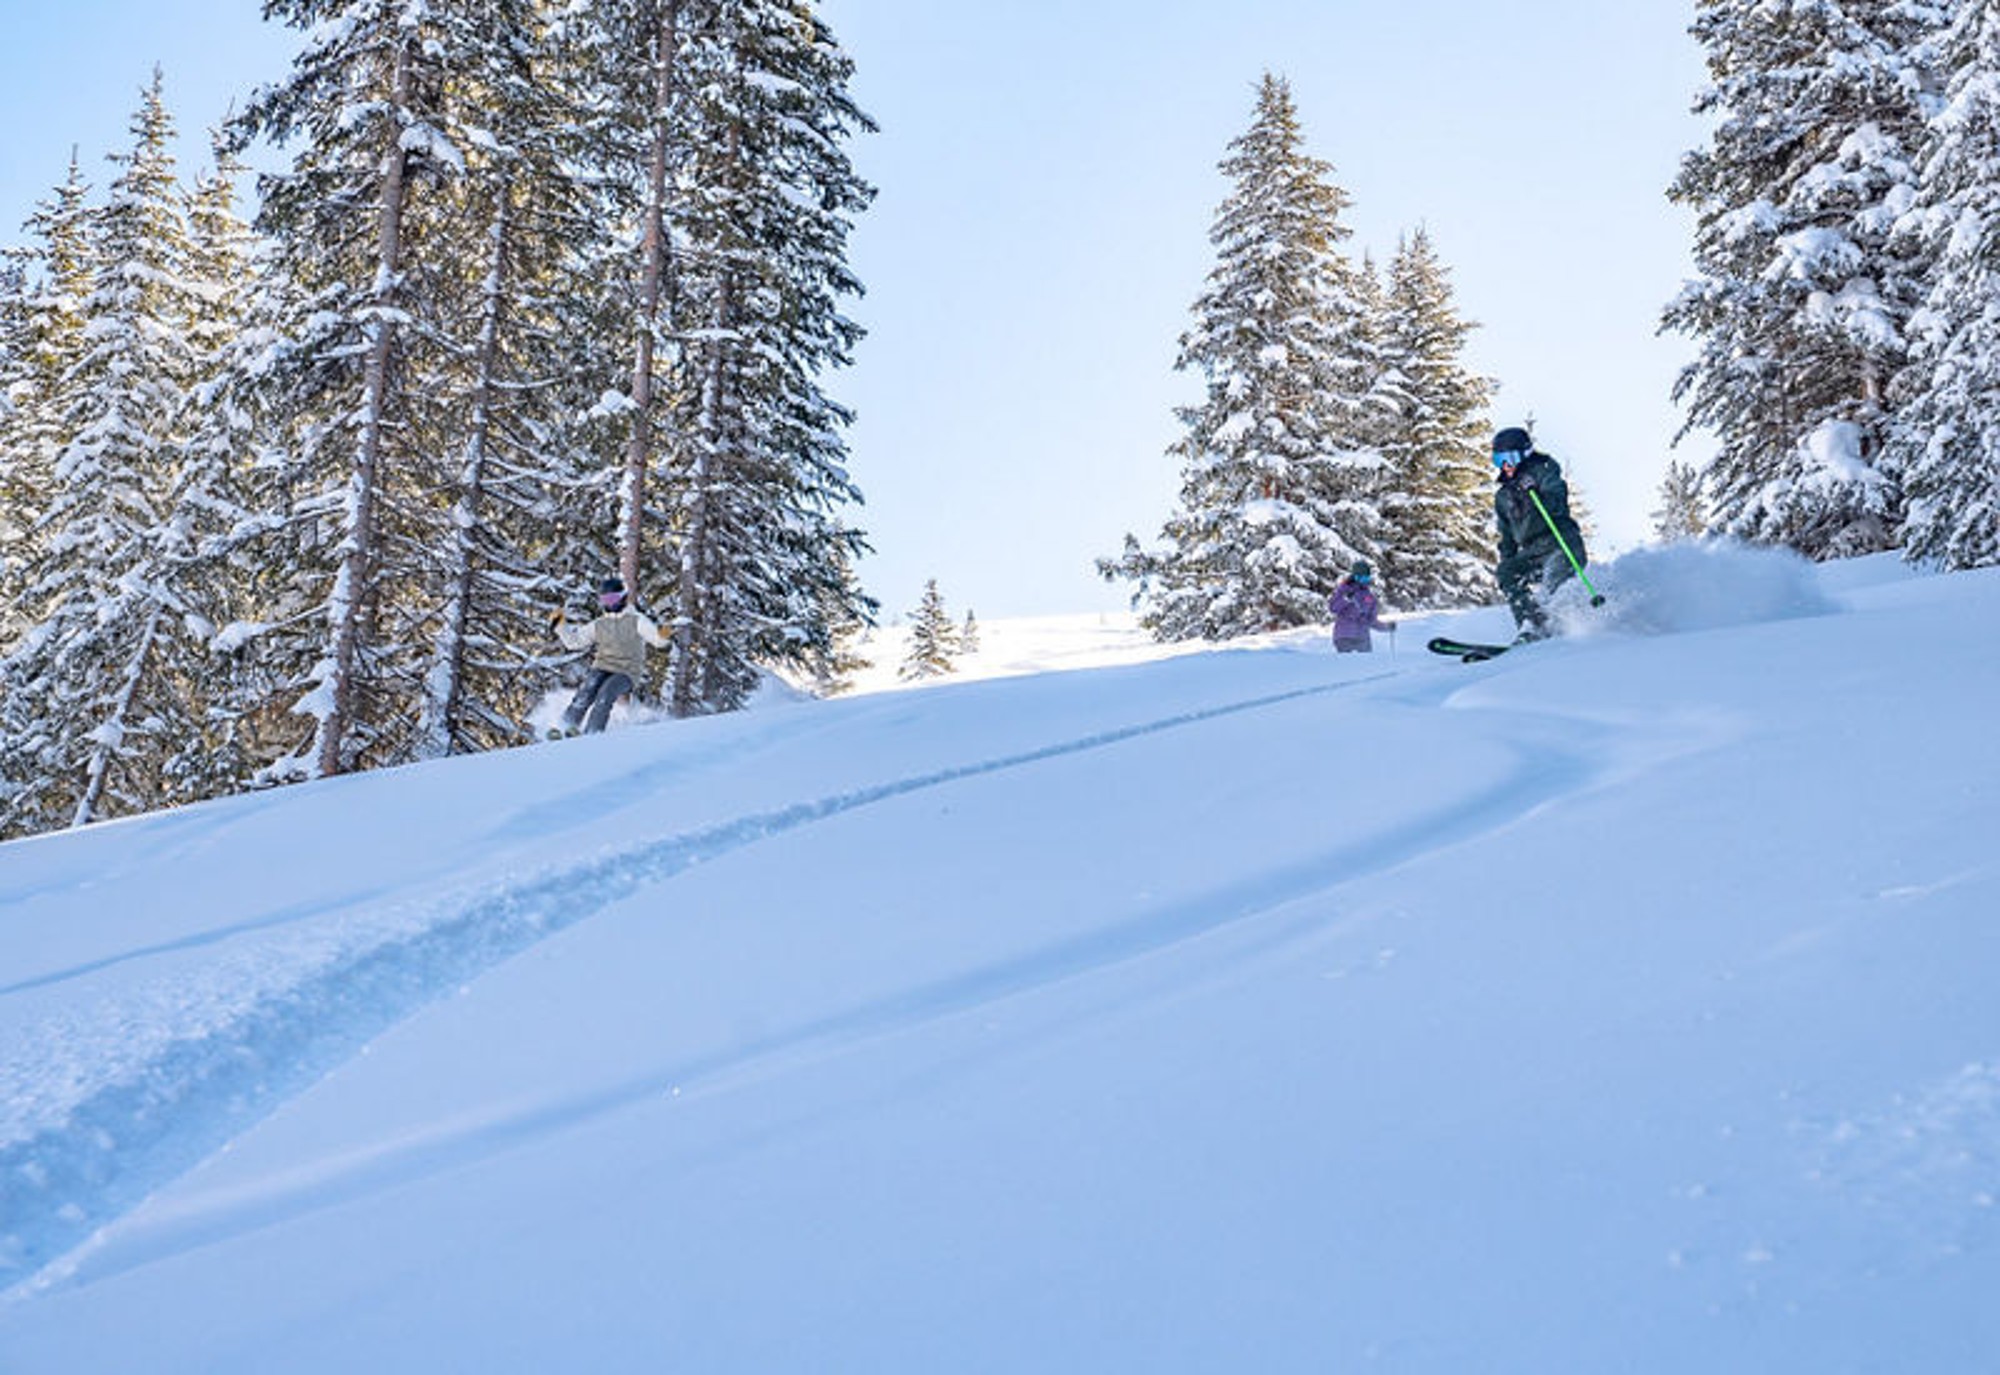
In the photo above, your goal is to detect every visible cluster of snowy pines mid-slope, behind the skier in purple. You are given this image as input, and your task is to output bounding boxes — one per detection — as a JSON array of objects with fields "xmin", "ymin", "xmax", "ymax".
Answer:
[{"xmin": 1098, "ymin": 74, "xmax": 1494, "ymax": 640}]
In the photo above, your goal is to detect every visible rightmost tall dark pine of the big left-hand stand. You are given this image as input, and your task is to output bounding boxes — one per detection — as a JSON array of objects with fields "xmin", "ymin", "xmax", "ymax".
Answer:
[{"xmin": 664, "ymin": 0, "xmax": 874, "ymax": 715}]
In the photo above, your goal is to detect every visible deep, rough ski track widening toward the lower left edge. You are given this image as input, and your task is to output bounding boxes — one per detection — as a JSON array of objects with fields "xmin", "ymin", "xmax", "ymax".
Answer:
[{"xmin": 0, "ymin": 674, "xmax": 1388, "ymax": 1283}]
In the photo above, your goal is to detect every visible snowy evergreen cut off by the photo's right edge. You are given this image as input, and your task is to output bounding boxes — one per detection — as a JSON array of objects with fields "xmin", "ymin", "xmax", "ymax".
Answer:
[{"xmin": 1896, "ymin": 2, "xmax": 2000, "ymax": 568}]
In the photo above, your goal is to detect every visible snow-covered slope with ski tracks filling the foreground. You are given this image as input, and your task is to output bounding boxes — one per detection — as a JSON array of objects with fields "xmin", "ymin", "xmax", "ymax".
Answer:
[{"xmin": 0, "ymin": 548, "xmax": 2000, "ymax": 1375}]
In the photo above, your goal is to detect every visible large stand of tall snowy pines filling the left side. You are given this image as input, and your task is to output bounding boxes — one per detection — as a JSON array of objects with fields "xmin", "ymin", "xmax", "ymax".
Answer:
[{"xmin": 0, "ymin": 0, "xmax": 874, "ymax": 835}]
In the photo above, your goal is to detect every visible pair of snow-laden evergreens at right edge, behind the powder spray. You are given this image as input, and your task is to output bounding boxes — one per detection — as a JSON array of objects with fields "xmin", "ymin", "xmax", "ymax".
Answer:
[{"xmin": 1662, "ymin": 0, "xmax": 2000, "ymax": 568}]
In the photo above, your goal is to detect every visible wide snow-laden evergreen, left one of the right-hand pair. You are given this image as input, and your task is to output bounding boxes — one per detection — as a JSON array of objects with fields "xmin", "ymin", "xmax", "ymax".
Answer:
[{"xmin": 1664, "ymin": 0, "xmax": 1942, "ymax": 558}]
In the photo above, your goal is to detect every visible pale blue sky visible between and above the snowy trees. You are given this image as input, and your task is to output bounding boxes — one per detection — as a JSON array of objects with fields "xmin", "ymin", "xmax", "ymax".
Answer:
[{"xmin": 0, "ymin": 0, "xmax": 1706, "ymax": 620}]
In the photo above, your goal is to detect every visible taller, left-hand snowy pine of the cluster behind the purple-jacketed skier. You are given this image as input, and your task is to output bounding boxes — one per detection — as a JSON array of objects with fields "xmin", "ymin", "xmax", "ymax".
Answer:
[{"xmin": 1098, "ymin": 74, "xmax": 1386, "ymax": 640}]
